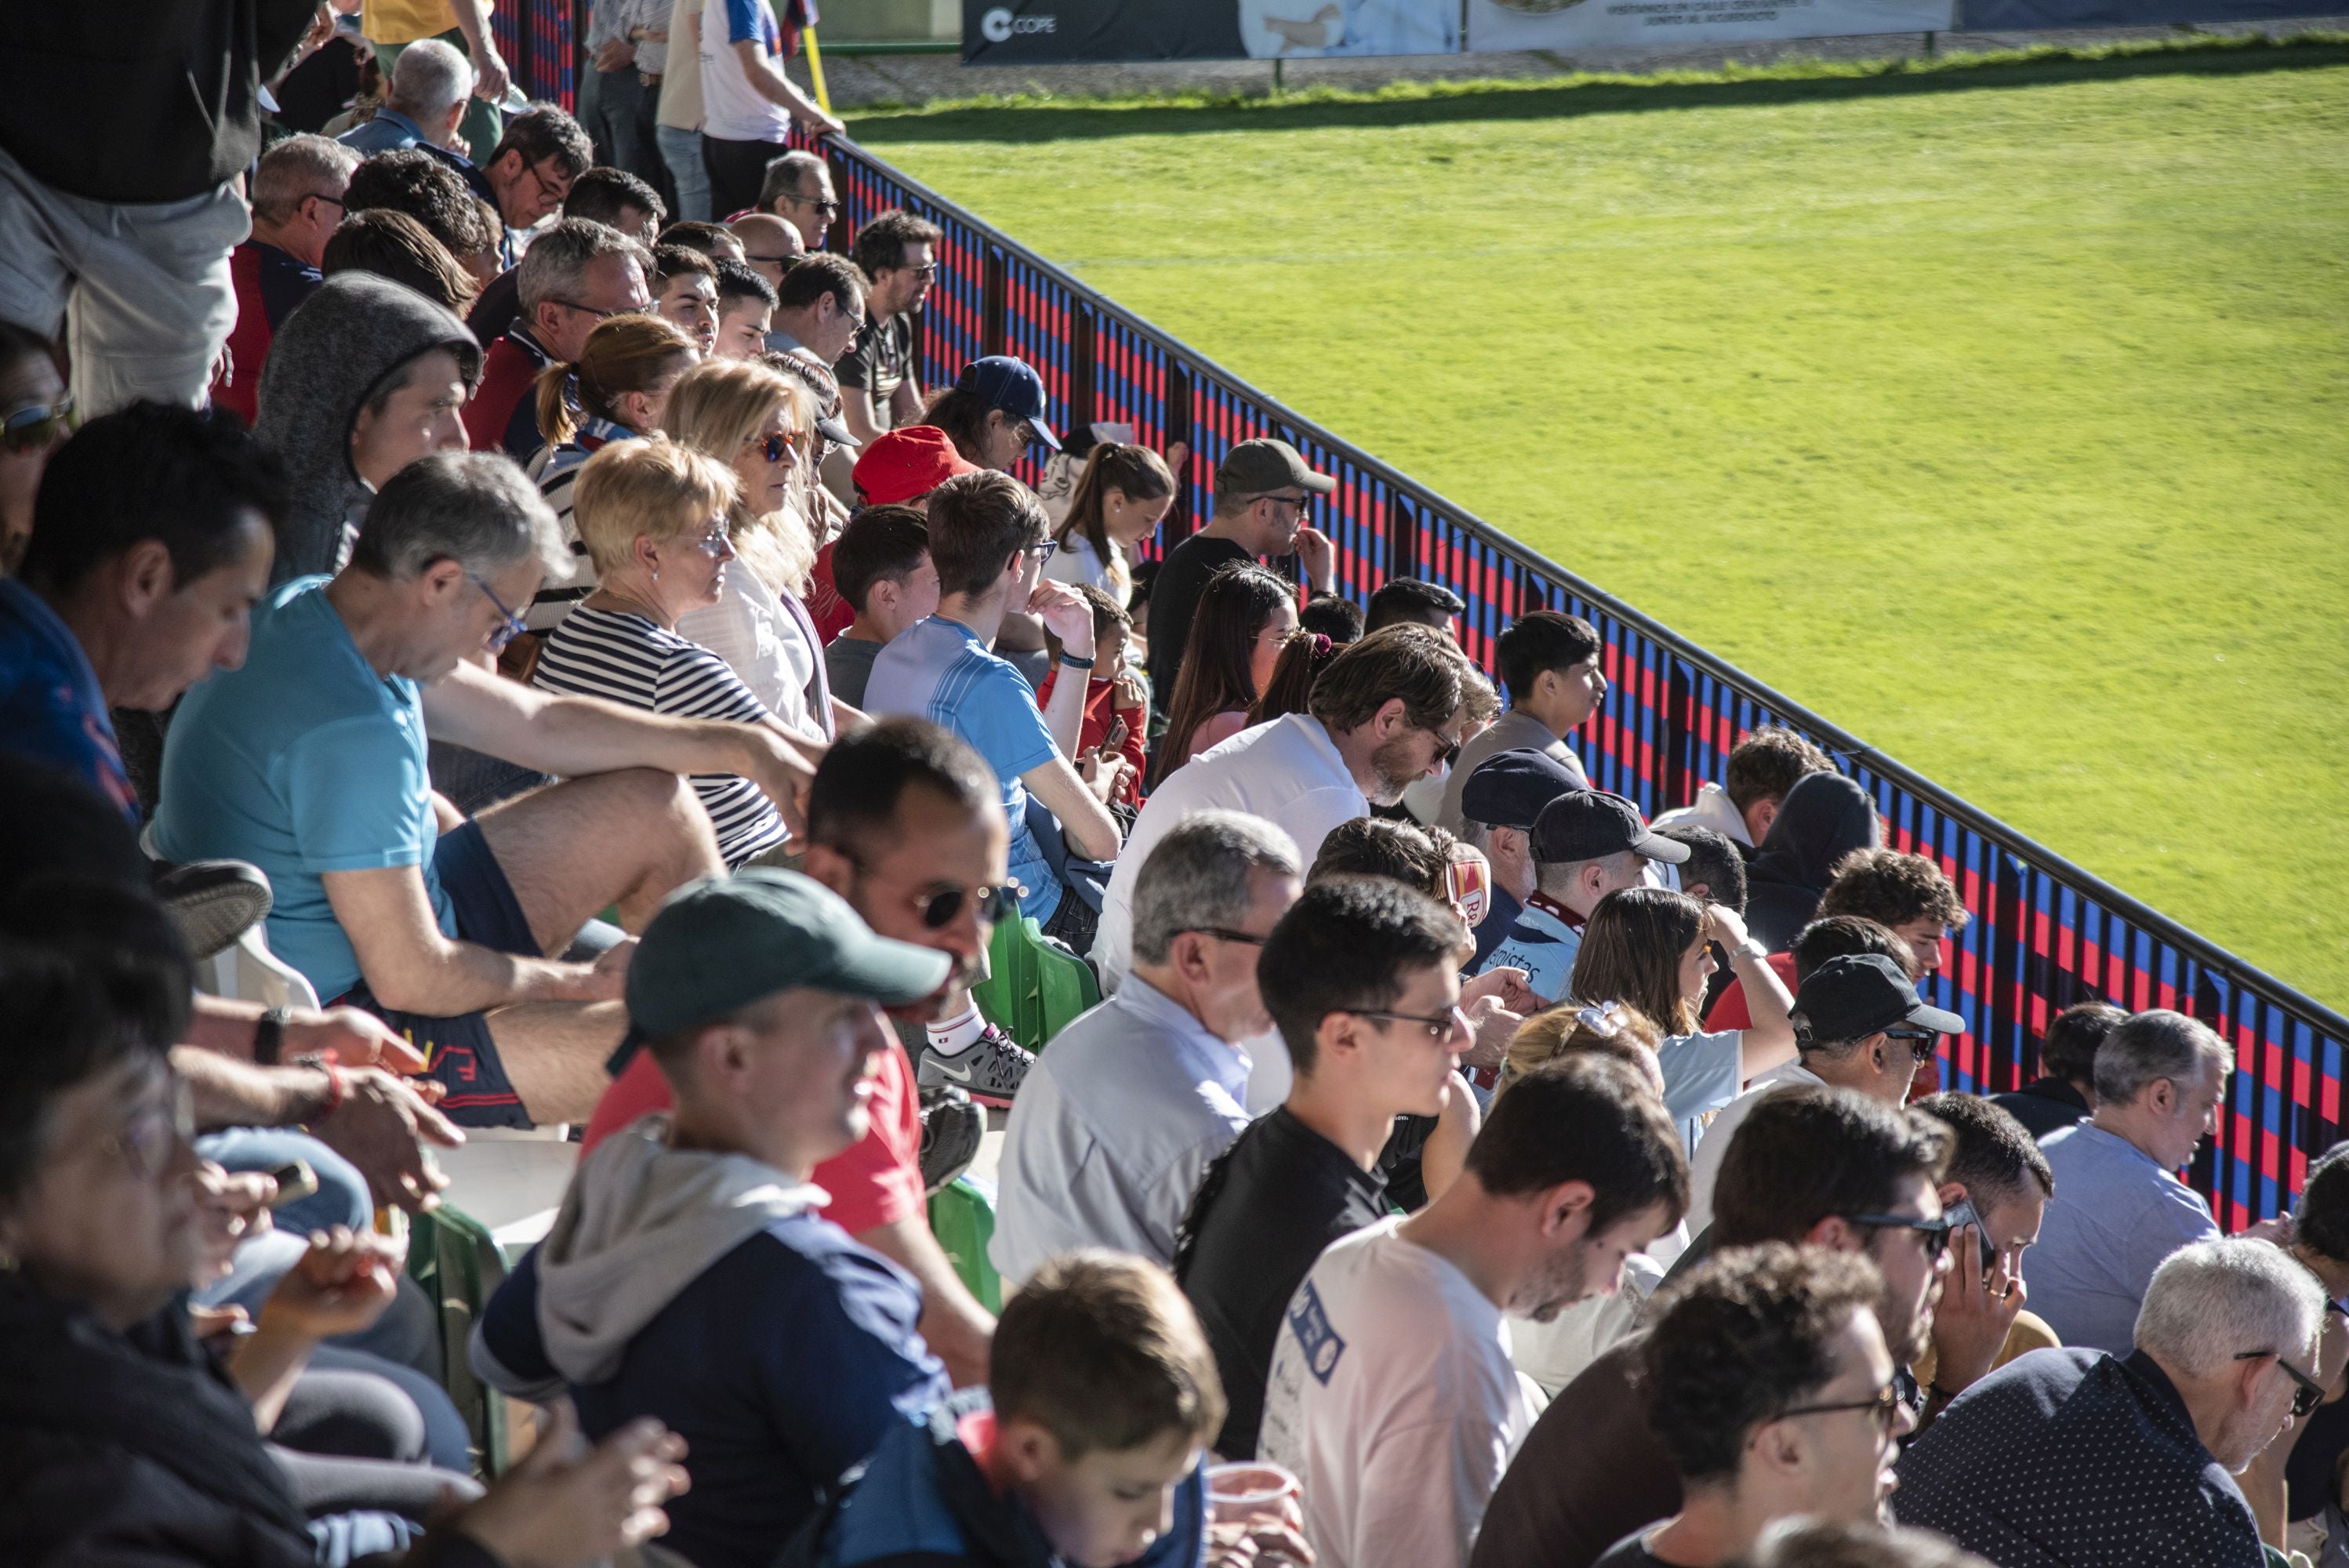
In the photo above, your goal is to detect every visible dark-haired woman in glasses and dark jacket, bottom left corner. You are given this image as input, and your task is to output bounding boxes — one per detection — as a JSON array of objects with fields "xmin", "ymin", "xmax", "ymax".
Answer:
[{"xmin": 0, "ymin": 924, "xmax": 684, "ymax": 1568}]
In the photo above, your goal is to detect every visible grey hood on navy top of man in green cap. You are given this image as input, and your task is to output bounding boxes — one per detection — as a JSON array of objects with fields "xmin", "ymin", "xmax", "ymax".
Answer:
[{"xmin": 538, "ymin": 1115, "xmax": 830, "ymax": 1382}]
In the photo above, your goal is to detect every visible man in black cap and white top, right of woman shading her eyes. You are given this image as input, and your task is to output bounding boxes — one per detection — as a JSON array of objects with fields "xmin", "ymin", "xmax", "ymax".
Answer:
[{"xmin": 1689, "ymin": 953, "xmax": 1966, "ymax": 1237}]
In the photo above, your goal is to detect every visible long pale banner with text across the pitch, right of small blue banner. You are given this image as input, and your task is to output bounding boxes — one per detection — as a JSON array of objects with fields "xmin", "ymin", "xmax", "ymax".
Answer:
[{"xmin": 1469, "ymin": 0, "xmax": 1955, "ymax": 54}]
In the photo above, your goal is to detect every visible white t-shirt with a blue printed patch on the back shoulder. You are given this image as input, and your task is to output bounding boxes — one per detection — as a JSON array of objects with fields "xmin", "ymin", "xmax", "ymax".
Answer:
[{"xmin": 1257, "ymin": 1218, "xmax": 1541, "ymax": 1568}]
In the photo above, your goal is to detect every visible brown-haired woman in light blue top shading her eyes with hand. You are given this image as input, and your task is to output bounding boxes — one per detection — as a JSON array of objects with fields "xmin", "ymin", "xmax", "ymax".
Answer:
[{"xmin": 1569, "ymin": 887, "xmax": 1795, "ymax": 1152}]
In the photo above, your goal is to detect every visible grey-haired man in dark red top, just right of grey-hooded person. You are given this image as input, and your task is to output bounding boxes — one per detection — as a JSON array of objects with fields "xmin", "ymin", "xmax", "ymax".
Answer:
[{"xmin": 465, "ymin": 218, "xmax": 653, "ymax": 463}]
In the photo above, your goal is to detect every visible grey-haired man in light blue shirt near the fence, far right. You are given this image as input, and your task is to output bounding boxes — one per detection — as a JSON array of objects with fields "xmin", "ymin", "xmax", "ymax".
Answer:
[{"xmin": 2032, "ymin": 1009, "xmax": 2234, "ymax": 1355}]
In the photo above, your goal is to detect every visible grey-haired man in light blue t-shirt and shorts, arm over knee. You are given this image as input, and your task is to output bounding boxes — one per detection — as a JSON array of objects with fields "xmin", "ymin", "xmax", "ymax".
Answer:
[{"xmin": 155, "ymin": 451, "xmax": 813, "ymax": 1127}]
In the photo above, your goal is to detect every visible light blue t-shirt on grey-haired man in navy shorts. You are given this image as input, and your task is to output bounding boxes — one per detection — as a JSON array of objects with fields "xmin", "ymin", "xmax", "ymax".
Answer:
[{"xmin": 155, "ymin": 578, "xmax": 456, "ymax": 1000}]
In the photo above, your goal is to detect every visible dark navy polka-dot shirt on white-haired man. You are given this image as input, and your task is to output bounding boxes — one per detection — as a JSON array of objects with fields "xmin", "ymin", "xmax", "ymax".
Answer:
[{"xmin": 1893, "ymin": 1352, "xmax": 2264, "ymax": 1568}]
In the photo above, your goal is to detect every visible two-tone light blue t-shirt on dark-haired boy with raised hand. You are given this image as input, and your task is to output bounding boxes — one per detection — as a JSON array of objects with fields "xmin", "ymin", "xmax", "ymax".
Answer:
[{"xmin": 865, "ymin": 615, "xmax": 1059, "ymax": 923}]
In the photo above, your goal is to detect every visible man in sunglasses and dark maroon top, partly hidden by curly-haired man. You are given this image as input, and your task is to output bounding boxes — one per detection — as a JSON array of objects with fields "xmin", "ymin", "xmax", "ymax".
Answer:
[{"xmin": 1470, "ymin": 1087, "xmax": 1950, "ymax": 1568}]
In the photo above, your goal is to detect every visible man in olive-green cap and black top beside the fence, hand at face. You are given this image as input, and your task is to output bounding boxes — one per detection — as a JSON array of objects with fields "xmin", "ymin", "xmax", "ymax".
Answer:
[{"xmin": 1151, "ymin": 441, "xmax": 1337, "ymax": 702}]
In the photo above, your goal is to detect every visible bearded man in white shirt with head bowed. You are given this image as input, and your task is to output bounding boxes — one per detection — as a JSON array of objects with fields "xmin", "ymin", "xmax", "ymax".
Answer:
[{"xmin": 1092, "ymin": 626, "xmax": 1498, "ymax": 990}]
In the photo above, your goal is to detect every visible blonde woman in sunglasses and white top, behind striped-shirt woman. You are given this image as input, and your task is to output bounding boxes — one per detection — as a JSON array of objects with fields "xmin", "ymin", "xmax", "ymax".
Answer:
[{"xmin": 663, "ymin": 359, "xmax": 862, "ymax": 739}]
